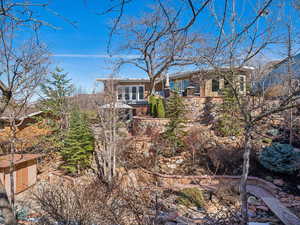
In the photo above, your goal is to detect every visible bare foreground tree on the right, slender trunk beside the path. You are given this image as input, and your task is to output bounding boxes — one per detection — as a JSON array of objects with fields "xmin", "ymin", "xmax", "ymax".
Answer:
[{"xmin": 200, "ymin": 0, "xmax": 300, "ymax": 224}]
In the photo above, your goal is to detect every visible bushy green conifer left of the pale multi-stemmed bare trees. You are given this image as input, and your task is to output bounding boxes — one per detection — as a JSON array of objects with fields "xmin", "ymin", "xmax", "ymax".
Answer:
[{"xmin": 61, "ymin": 111, "xmax": 94, "ymax": 173}]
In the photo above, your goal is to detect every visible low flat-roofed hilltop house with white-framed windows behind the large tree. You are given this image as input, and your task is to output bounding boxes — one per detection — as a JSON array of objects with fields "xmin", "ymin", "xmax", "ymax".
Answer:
[{"xmin": 97, "ymin": 67, "xmax": 252, "ymax": 115}]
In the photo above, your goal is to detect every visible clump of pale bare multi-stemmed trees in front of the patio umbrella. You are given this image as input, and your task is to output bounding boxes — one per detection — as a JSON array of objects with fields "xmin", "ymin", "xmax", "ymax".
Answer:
[{"xmin": 94, "ymin": 76, "xmax": 132, "ymax": 185}]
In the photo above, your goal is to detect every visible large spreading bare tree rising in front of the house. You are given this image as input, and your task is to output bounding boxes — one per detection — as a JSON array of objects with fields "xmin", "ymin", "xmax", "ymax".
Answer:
[{"xmin": 113, "ymin": 7, "xmax": 203, "ymax": 94}]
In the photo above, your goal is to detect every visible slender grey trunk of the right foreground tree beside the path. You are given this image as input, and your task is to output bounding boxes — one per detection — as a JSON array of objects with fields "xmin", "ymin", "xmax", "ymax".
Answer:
[{"xmin": 240, "ymin": 127, "xmax": 252, "ymax": 225}]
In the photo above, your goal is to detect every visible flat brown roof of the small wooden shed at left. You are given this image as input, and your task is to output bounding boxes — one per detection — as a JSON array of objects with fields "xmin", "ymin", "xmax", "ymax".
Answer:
[{"xmin": 0, "ymin": 154, "xmax": 42, "ymax": 168}]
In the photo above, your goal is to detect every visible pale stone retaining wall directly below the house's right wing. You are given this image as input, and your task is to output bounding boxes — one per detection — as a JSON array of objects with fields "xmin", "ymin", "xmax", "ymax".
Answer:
[{"xmin": 184, "ymin": 96, "xmax": 222, "ymax": 122}]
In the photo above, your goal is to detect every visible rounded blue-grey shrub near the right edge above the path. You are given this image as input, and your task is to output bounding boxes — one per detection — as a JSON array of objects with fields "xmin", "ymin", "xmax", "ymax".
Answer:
[{"xmin": 259, "ymin": 143, "xmax": 299, "ymax": 173}]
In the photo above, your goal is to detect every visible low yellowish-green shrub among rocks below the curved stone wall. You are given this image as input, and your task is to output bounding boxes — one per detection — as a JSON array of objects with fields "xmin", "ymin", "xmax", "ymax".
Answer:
[{"xmin": 177, "ymin": 188, "xmax": 204, "ymax": 208}]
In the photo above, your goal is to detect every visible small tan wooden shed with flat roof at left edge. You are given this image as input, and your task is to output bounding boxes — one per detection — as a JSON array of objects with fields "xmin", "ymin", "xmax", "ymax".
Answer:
[{"xmin": 0, "ymin": 154, "xmax": 41, "ymax": 195}]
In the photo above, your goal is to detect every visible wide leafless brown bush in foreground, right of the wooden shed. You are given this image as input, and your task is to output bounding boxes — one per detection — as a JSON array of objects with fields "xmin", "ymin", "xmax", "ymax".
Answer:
[{"xmin": 34, "ymin": 181, "xmax": 155, "ymax": 225}]
